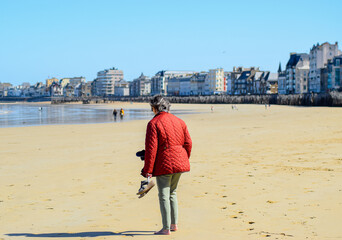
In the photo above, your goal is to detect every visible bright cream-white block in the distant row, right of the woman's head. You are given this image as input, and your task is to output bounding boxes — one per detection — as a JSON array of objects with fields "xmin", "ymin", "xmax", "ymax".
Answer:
[{"xmin": 205, "ymin": 68, "xmax": 226, "ymax": 95}]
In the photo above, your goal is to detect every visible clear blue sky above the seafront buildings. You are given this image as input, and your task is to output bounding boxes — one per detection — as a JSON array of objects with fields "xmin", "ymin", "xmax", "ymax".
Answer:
[{"xmin": 0, "ymin": 0, "xmax": 342, "ymax": 85}]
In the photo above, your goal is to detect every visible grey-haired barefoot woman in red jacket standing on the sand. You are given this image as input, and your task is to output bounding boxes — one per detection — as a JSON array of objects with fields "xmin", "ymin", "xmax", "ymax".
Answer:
[{"xmin": 142, "ymin": 95, "xmax": 192, "ymax": 235}]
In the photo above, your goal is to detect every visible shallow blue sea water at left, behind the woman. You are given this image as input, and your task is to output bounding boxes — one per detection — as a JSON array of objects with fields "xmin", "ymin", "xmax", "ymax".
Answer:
[{"xmin": 0, "ymin": 103, "xmax": 190, "ymax": 128}]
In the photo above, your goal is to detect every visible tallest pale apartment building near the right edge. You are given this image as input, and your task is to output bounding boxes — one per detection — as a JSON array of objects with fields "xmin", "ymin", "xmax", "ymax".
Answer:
[{"xmin": 309, "ymin": 42, "xmax": 341, "ymax": 93}]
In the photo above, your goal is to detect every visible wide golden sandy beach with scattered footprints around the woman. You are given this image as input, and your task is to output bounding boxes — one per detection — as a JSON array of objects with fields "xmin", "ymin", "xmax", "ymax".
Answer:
[{"xmin": 0, "ymin": 104, "xmax": 342, "ymax": 240}]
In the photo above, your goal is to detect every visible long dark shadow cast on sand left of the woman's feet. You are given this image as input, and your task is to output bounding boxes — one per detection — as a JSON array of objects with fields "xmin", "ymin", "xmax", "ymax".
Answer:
[{"xmin": 6, "ymin": 231, "xmax": 154, "ymax": 238}]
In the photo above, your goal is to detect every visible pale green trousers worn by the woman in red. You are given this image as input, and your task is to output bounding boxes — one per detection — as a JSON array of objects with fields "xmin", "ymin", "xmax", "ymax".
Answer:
[{"xmin": 157, "ymin": 173, "xmax": 182, "ymax": 230}]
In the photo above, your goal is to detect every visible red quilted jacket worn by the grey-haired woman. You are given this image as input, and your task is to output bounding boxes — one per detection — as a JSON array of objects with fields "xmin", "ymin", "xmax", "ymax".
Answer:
[{"xmin": 142, "ymin": 112, "xmax": 192, "ymax": 176}]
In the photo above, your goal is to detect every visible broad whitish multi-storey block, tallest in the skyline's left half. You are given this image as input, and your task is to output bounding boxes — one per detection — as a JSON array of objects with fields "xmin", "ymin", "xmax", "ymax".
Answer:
[{"xmin": 93, "ymin": 68, "xmax": 124, "ymax": 96}]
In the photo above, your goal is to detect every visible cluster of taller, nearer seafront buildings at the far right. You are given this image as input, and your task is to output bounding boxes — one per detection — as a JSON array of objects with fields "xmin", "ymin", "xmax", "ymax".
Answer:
[{"xmin": 278, "ymin": 42, "xmax": 342, "ymax": 94}]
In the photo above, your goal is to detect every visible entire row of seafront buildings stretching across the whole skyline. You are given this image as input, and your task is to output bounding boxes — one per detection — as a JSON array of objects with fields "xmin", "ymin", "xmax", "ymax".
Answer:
[{"xmin": 0, "ymin": 42, "xmax": 342, "ymax": 97}]
